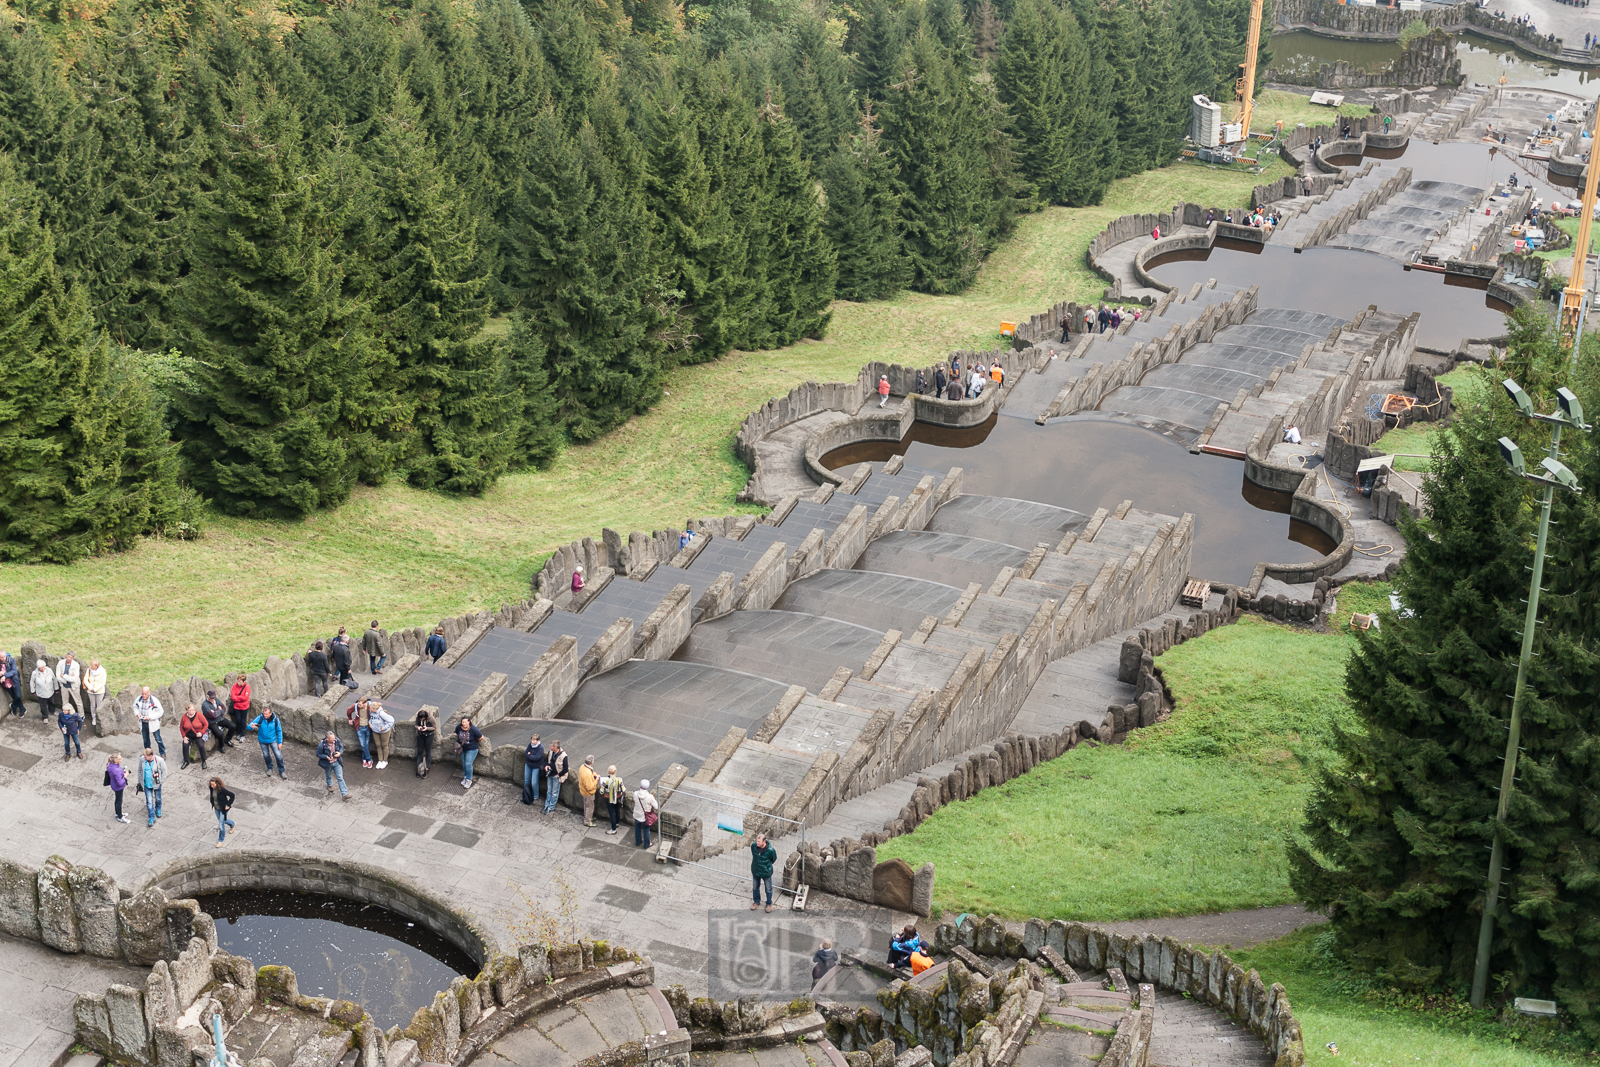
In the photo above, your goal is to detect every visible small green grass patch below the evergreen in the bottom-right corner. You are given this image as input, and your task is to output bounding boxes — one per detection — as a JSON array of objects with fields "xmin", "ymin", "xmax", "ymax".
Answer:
[{"xmin": 1229, "ymin": 926, "xmax": 1592, "ymax": 1067}]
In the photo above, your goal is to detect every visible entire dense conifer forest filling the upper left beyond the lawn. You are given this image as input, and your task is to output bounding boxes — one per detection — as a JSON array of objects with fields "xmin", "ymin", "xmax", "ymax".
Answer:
[{"xmin": 0, "ymin": 0, "xmax": 1273, "ymax": 561}]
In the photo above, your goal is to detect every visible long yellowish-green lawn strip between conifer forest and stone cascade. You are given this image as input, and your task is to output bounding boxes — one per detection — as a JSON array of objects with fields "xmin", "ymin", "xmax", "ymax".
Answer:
[{"xmin": 0, "ymin": 163, "xmax": 1286, "ymax": 689}]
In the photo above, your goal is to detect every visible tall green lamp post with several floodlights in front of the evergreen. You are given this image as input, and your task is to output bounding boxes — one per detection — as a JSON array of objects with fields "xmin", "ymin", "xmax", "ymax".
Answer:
[{"xmin": 1472, "ymin": 382, "xmax": 1589, "ymax": 1008}]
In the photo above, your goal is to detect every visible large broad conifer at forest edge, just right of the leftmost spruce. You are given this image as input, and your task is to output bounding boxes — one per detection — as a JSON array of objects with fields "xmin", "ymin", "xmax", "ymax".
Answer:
[{"xmin": 178, "ymin": 90, "xmax": 382, "ymax": 517}]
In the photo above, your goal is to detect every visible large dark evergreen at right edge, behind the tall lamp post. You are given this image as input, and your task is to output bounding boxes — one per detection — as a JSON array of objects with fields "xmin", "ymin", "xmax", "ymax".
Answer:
[{"xmin": 1290, "ymin": 312, "xmax": 1600, "ymax": 1033}]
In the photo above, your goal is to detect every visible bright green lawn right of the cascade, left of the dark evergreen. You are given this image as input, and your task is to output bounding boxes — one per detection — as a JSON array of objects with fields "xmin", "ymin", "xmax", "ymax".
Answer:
[{"xmin": 878, "ymin": 585, "xmax": 1387, "ymax": 921}]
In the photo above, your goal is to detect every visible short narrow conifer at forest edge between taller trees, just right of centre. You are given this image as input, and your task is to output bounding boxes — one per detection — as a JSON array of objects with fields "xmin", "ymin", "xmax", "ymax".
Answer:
[{"xmin": 821, "ymin": 110, "xmax": 910, "ymax": 301}]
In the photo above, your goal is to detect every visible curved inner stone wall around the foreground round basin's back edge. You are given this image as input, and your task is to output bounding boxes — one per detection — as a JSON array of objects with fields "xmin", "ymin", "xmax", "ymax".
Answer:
[{"xmin": 147, "ymin": 849, "xmax": 499, "ymax": 966}]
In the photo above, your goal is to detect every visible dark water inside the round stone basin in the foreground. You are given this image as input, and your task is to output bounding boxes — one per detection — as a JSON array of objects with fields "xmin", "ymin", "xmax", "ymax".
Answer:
[{"xmin": 198, "ymin": 889, "xmax": 478, "ymax": 1030}]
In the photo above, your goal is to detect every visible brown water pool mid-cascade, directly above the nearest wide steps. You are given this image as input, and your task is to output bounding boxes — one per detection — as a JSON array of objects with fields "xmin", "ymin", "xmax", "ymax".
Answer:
[{"xmin": 822, "ymin": 414, "xmax": 1336, "ymax": 584}]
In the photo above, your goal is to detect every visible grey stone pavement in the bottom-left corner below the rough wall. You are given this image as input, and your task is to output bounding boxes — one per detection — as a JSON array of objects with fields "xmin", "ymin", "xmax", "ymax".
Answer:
[{"xmin": 0, "ymin": 934, "xmax": 149, "ymax": 1067}]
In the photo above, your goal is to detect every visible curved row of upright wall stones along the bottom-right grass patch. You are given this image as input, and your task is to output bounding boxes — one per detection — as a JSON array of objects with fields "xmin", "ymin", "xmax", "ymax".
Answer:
[{"xmin": 928, "ymin": 915, "xmax": 1306, "ymax": 1067}]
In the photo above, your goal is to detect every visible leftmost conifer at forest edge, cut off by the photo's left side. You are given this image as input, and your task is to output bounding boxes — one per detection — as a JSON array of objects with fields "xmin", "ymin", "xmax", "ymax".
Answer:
[{"xmin": 0, "ymin": 155, "xmax": 179, "ymax": 563}]
